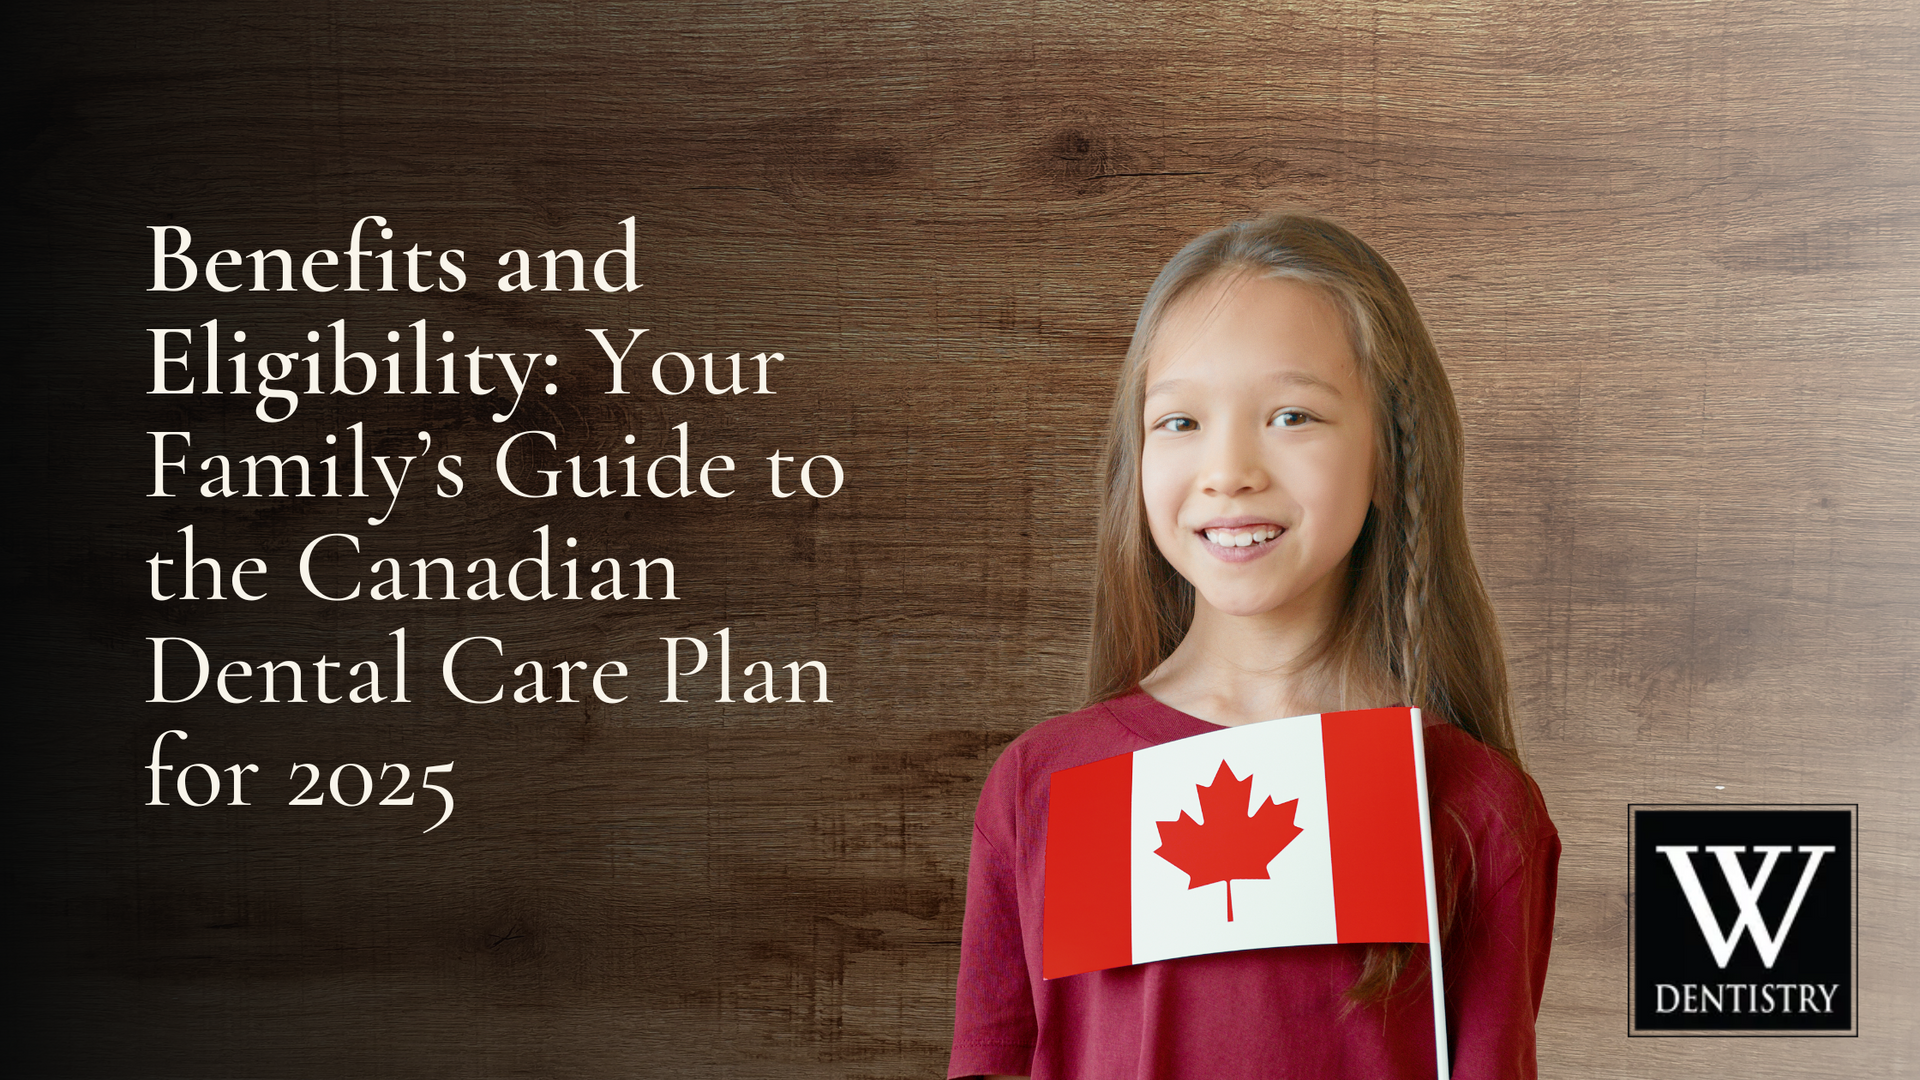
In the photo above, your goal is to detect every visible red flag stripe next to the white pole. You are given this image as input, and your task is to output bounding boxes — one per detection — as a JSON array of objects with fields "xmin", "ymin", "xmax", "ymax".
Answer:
[{"xmin": 1321, "ymin": 709, "xmax": 1427, "ymax": 942}]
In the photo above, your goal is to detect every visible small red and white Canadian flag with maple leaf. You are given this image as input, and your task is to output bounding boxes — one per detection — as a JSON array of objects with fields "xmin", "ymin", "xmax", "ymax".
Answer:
[{"xmin": 1041, "ymin": 709, "xmax": 1446, "ymax": 980}]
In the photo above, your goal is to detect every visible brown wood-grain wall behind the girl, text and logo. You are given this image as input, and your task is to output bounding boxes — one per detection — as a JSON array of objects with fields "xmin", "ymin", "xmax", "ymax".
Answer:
[{"xmin": 8, "ymin": 0, "xmax": 1920, "ymax": 1078}]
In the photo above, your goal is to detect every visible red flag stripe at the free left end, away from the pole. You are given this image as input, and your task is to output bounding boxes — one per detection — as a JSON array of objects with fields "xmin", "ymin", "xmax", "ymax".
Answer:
[{"xmin": 1041, "ymin": 753, "xmax": 1133, "ymax": 978}]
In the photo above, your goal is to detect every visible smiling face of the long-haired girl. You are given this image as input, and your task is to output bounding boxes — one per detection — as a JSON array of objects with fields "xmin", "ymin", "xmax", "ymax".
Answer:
[{"xmin": 1140, "ymin": 275, "xmax": 1375, "ymax": 617}]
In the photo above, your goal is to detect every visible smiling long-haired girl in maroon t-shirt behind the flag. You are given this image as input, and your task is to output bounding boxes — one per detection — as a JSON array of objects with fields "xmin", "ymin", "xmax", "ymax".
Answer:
[{"xmin": 948, "ymin": 213, "xmax": 1559, "ymax": 1080}]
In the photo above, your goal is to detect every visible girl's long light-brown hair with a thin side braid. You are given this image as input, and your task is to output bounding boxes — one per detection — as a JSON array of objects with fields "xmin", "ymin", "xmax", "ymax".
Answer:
[{"xmin": 1087, "ymin": 213, "xmax": 1519, "ymax": 999}]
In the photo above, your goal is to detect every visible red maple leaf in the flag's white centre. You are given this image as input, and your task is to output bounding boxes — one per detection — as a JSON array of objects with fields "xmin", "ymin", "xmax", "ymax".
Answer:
[{"xmin": 1154, "ymin": 761, "xmax": 1300, "ymax": 922}]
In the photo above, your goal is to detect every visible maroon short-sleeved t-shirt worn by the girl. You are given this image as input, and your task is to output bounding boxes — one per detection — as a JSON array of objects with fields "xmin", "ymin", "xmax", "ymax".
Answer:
[{"xmin": 947, "ymin": 692, "xmax": 1559, "ymax": 1080}]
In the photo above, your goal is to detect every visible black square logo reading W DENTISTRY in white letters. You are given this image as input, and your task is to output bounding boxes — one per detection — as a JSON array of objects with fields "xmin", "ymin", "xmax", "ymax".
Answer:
[{"xmin": 1628, "ymin": 805, "xmax": 1860, "ymax": 1036}]
